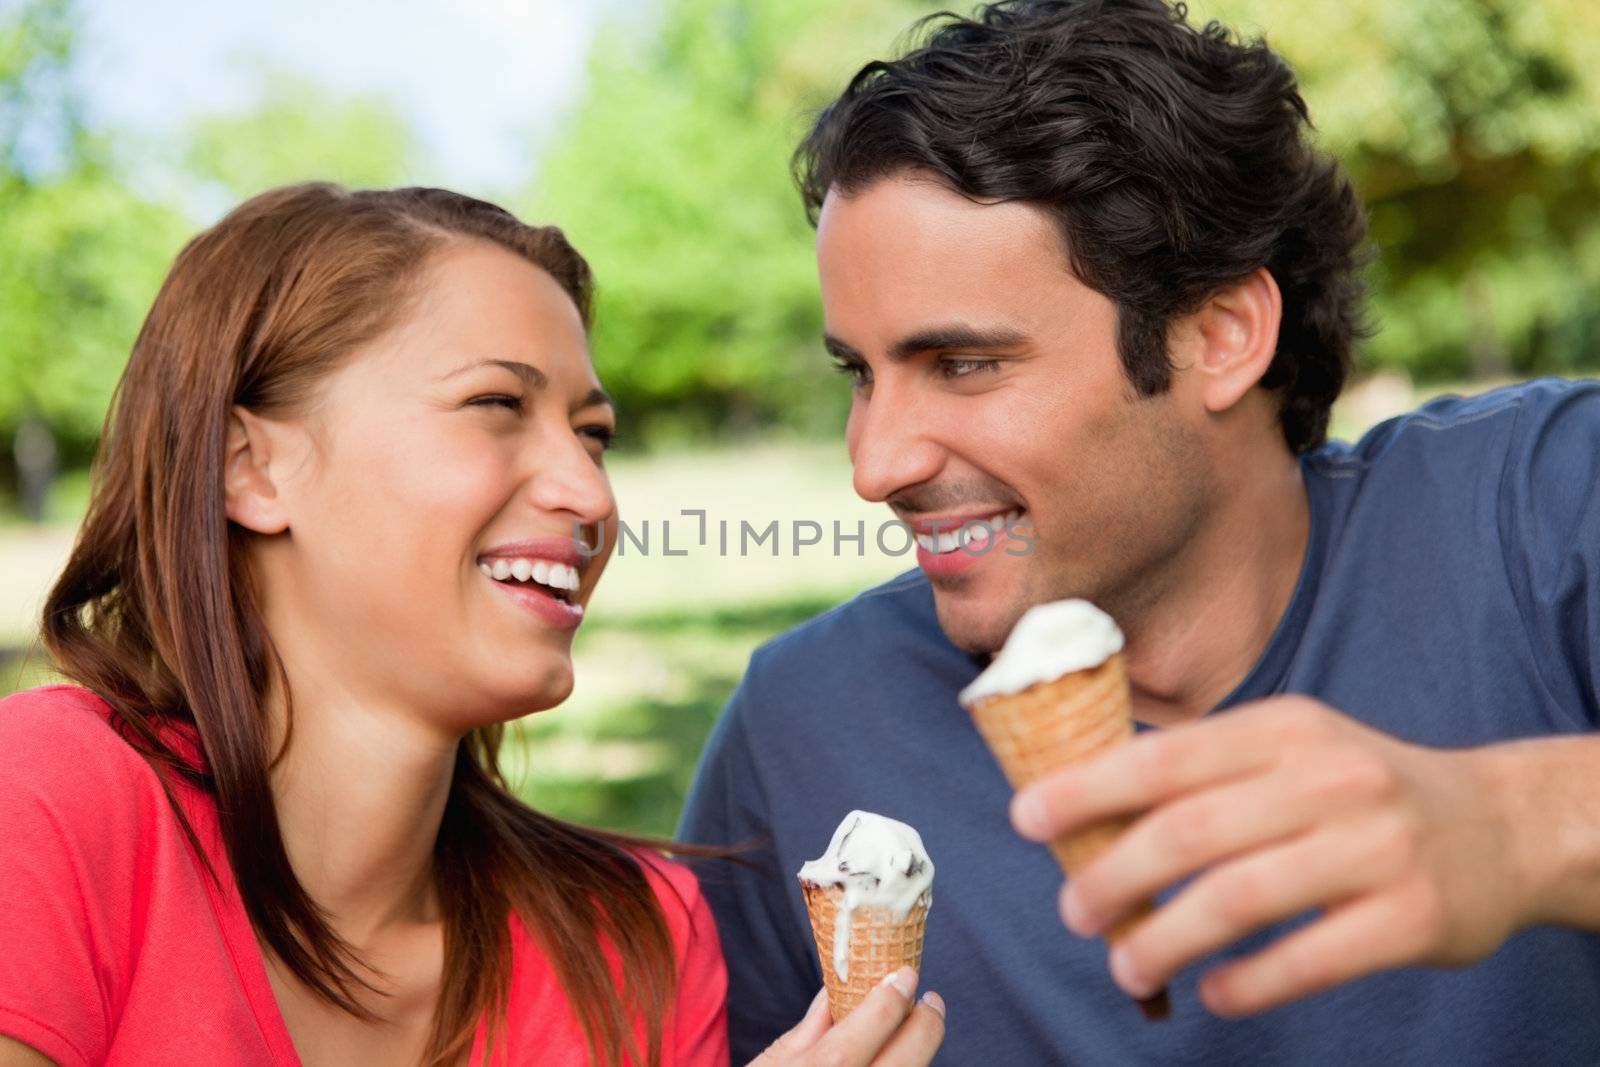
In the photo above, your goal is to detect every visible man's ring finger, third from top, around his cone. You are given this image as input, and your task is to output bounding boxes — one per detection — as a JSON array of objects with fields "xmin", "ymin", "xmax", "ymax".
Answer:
[{"xmin": 1110, "ymin": 824, "xmax": 1400, "ymax": 997}]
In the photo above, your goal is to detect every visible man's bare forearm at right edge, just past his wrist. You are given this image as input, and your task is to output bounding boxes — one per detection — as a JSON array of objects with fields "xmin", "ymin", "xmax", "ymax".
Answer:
[{"xmin": 1477, "ymin": 736, "xmax": 1600, "ymax": 931}]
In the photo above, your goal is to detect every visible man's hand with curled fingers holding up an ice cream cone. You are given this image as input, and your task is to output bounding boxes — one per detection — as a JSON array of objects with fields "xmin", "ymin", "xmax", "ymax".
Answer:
[{"xmin": 1011, "ymin": 696, "xmax": 1536, "ymax": 1016}]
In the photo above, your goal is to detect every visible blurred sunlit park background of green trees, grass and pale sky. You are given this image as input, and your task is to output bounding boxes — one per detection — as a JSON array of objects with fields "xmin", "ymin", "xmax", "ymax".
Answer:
[{"xmin": 0, "ymin": 0, "xmax": 1600, "ymax": 832}]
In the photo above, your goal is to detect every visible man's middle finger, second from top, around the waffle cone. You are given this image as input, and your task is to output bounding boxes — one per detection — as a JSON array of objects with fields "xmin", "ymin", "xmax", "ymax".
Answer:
[{"xmin": 1061, "ymin": 774, "xmax": 1328, "ymax": 937}]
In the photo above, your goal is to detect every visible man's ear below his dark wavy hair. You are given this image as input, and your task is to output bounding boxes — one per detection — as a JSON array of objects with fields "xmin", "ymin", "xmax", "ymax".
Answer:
[{"xmin": 1190, "ymin": 267, "xmax": 1283, "ymax": 414}]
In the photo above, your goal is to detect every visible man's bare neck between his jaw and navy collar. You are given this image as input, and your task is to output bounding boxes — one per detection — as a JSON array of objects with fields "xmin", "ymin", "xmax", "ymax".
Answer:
[{"xmin": 1123, "ymin": 453, "xmax": 1310, "ymax": 726}]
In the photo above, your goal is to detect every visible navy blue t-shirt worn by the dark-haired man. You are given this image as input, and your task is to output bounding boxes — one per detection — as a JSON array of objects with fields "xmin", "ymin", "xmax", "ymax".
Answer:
[{"xmin": 680, "ymin": 381, "xmax": 1600, "ymax": 1067}]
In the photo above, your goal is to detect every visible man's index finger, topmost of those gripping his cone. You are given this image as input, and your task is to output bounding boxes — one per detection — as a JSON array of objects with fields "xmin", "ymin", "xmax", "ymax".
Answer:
[{"xmin": 1011, "ymin": 705, "xmax": 1277, "ymax": 841}]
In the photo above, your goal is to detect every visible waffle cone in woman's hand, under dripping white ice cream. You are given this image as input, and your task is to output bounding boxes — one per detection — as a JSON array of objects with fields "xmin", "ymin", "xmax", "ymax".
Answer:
[{"xmin": 800, "ymin": 880, "xmax": 931, "ymax": 1022}]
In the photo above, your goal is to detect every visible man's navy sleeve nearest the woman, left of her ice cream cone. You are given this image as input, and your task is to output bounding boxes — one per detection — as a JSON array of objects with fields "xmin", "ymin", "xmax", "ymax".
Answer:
[{"xmin": 678, "ymin": 671, "xmax": 819, "ymax": 1064}]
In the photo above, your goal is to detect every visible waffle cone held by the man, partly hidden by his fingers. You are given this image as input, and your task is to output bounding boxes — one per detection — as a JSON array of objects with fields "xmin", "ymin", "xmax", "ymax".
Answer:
[{"xmin": 968, "ymin": 653, "xmax": 1165, "ymax": 1017}]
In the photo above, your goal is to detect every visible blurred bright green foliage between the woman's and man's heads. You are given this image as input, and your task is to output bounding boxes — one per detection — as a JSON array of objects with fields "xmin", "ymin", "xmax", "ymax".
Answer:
[{"xmin": 528, "ymin": 0, "xmax": 931, "ymax": 438}]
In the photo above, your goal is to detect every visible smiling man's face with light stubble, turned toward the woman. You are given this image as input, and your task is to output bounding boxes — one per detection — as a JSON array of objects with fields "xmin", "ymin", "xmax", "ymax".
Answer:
[{"xmin": 818, "ymin": 176, "xmax": 1210, "ymax": 653}]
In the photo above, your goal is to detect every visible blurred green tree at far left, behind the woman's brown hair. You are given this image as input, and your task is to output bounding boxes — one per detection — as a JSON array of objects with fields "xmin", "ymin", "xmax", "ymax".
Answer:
[{"xmin": 0, "ymin": 0, "xmax": 184, "ymax": 518}]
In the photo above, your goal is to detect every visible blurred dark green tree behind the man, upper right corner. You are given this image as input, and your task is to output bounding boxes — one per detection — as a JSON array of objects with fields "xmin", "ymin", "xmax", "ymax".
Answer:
[{"xmin": 1190, "ymin": 0, "xmax": 1600, "ymax": 379}]
